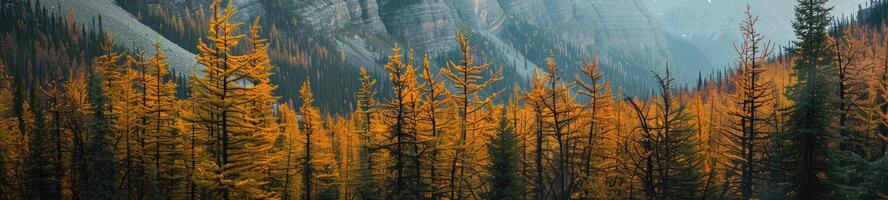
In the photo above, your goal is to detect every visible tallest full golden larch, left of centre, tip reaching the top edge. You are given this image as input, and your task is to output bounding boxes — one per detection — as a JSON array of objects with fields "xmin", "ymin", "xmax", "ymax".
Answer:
[{"xmin": 188, "ymin": 0, "xmax": 273, "ymax": 200}]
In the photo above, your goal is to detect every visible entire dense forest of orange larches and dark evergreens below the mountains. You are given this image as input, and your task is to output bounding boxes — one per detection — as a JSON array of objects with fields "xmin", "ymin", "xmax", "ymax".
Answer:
[{"xmin": 0, "ymin": 0, "xmax": 888, "ymax": 200}]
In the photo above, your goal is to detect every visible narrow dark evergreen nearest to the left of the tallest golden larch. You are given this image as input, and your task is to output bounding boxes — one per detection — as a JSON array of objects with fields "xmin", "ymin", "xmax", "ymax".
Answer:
[{"xmin": 86, "ymin": 73, "xmax": 118, "ymax": 200}]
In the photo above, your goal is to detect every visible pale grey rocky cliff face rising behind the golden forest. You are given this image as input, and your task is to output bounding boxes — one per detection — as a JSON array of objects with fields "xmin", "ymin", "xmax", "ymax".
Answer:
[{"xmin": 237, "ymin": 0, "xmax": 692, "ymax": 86}]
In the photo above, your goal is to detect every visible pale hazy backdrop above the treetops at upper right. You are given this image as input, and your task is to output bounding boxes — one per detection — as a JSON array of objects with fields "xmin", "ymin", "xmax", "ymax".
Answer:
[{"xmin": 640, "ymin": 0, "xmax": 869, "ymax": 66}]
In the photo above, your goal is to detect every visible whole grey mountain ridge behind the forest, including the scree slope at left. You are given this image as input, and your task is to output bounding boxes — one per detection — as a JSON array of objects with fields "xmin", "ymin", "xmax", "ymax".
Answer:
[{"xmin": 45, "ymin": 0, "xmax": 709, "ymax": 111}]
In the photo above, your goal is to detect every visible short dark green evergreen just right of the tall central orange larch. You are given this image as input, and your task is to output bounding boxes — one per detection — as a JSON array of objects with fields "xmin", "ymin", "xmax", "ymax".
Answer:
[{"xmin": 484, "ymin": 111, "xmax": 524, "ymax": 200}]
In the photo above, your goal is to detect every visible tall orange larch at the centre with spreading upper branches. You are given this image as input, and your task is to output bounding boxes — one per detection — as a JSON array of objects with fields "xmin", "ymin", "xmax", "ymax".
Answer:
[{"xmin": 441, "ymin": 29, "xmax": 501, "ymax": 199}]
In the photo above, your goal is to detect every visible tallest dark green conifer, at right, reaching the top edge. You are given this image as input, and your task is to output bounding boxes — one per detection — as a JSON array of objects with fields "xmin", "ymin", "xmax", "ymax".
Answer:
[{"xmin": 774, "ymin": 0, "xmax": 838, "ymax": 199}]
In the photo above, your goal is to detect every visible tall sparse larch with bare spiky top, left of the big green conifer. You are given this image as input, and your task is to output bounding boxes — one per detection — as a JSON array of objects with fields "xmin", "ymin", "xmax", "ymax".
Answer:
[{"xmin": 724, "ymin": 6, "xmax": 772, "ymax": 200}]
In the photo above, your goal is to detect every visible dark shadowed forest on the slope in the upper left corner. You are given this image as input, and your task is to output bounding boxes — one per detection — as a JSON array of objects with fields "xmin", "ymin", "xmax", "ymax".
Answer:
[{"xmin": 0, "ymin": 1, "xmax": 108, "ymax": 89}]
